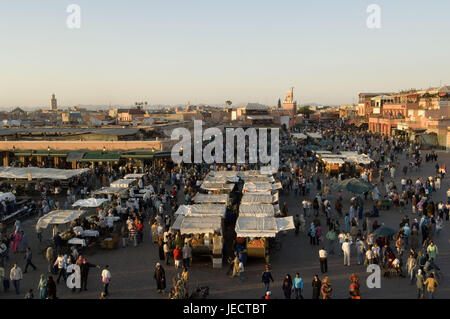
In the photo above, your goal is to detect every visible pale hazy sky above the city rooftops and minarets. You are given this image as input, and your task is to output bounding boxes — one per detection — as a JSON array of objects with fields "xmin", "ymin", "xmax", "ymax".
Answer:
[{"xmin": 0, "ymin": 0, "xmax": 450, "ymax": 108}]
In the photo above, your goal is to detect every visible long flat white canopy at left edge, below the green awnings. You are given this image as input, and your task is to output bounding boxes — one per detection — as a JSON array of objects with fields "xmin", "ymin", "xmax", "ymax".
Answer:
[{"xmin": 0, "ymin": 167, "xmax": 90, "ymax": 180}]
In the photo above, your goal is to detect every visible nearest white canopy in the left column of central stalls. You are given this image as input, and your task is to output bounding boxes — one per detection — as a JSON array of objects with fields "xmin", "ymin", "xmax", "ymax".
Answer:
[{"xmin": 172, "ymin": 215, "xmax": 222, "ymax": 235}]
